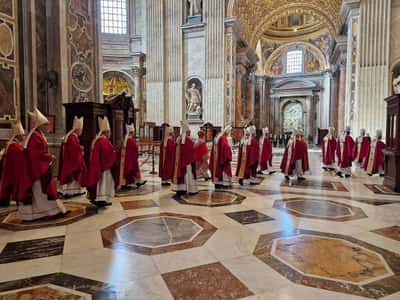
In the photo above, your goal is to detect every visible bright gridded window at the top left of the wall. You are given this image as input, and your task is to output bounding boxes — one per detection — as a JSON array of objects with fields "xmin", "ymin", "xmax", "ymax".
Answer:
[{"xmin": 101, "ymin": 0, "xmax": 128, "ymax": 34}]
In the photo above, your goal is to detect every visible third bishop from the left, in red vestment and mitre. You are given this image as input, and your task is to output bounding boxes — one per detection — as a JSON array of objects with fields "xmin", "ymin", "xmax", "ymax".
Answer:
[{"xmin": 58, "ymin": 116, "xmax": 86, "ymax": 198}]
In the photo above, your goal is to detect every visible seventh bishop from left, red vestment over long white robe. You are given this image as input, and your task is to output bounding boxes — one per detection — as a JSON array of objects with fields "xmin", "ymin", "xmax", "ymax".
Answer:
[{"xmin": 172, "ymin": 121, "xmax": 198, "ymax": 195}]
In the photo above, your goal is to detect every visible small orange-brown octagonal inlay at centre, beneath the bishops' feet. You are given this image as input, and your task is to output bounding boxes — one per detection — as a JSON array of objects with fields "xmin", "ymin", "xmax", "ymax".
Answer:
[{"xmin": 175, "ymin": 190, "xmax": 246, "ymax": 207}]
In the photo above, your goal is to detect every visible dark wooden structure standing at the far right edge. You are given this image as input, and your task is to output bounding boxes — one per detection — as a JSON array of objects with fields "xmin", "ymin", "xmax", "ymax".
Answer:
[{"xmin": 383, "ymin": 95, "xmax": 400, "ymax": 192}]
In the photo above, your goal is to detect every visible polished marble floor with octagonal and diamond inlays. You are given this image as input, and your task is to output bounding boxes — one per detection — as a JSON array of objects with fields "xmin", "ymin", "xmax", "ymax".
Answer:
[{"xmin": 0, "ymin": 151, "xmax": 400, "ymax": 300}]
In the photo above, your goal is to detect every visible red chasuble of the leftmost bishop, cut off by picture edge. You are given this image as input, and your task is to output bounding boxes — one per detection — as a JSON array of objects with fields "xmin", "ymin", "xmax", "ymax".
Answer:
[{"xmin": 0, "ymin": 141, "xmax": 24, "ymax": 204}]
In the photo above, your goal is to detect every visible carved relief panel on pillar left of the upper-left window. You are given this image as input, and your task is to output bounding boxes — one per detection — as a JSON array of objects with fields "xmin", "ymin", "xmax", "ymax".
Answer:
[{"xmin": 67, "ymin": 0, "xmax": 97, "ymax": 102}]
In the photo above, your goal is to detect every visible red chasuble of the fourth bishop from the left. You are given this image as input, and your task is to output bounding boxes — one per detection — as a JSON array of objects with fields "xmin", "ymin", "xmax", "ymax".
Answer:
[{"xmin": 85, "ymin": 136, "xmax": 117, "ymax": 188}]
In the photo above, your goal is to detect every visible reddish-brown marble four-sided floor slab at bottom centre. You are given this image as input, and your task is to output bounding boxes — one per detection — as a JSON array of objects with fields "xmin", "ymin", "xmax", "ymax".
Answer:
[{"xmin": 162, "ymin": 263, "xmax": 253, "ymax": 300}]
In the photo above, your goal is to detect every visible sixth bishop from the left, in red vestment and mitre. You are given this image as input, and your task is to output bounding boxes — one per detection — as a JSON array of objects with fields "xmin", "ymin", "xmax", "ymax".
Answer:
[{"xmin": 158, "ymin": 126, "xmax": 175, "ymax": 186}]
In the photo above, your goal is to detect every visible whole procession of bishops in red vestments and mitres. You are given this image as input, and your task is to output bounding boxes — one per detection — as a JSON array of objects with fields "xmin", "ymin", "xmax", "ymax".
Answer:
[{"xmin": 0, "ymin": 109, "xmax": 385, "ymax": 221}]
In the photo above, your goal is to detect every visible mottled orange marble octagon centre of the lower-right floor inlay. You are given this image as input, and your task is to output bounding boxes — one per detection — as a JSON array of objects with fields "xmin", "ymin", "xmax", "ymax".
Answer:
[{"xmin": 271, "ymin": 235, "xmax": 393, "ymax": 284}]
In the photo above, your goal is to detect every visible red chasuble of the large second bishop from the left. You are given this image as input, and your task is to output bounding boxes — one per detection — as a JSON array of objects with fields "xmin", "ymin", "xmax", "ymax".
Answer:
[{"xmin": 18, "ymin": 130, "xmax": 58, "ymax": 204}]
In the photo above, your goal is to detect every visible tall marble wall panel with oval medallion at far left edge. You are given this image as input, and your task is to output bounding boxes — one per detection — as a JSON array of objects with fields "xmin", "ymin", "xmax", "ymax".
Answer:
[{"xmin": 0, "ymin": 0, "xmax": 19, "ymax": 122}]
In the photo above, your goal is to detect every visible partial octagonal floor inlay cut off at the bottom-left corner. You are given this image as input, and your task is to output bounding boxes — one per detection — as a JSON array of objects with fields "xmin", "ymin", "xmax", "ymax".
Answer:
[{"xmin": 0, "ymin": 273, "xmax": 117, "ymax": 300}]
